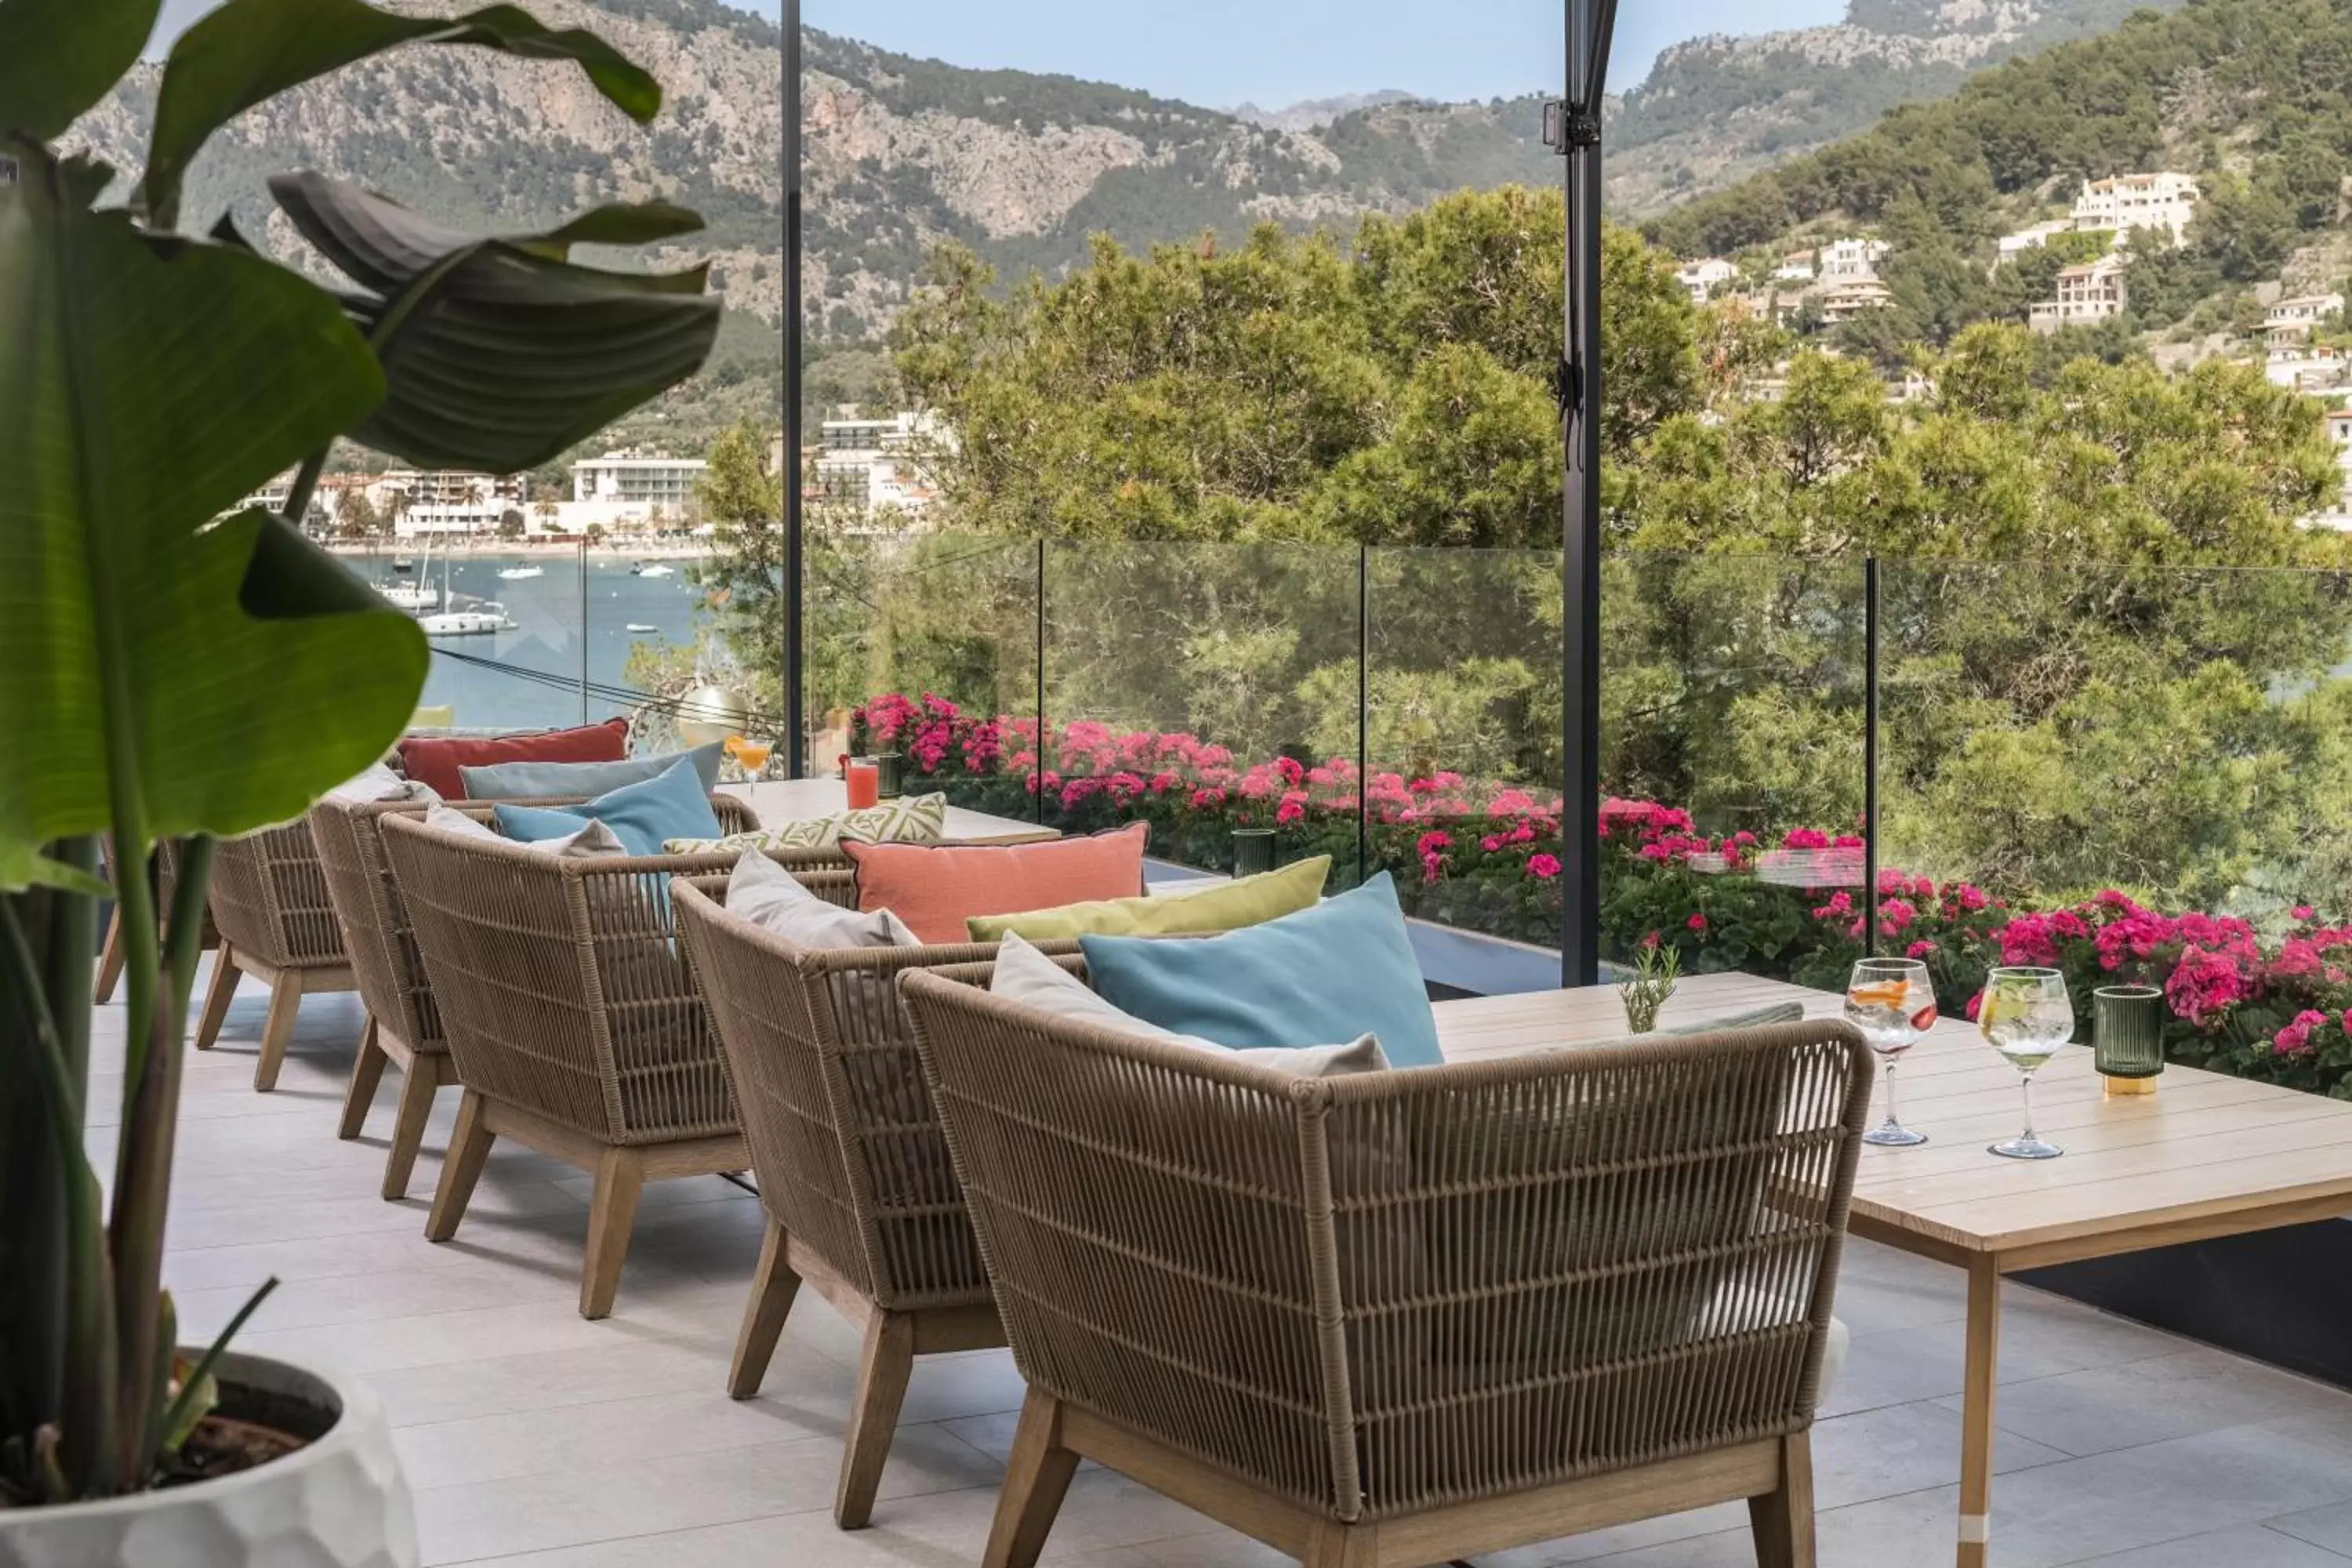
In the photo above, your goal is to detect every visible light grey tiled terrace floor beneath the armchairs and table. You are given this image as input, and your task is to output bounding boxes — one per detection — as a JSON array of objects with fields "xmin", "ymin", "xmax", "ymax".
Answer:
[{"xmin": 106, "ymin": 959, "xmax": 2352, "ymax": 1568}]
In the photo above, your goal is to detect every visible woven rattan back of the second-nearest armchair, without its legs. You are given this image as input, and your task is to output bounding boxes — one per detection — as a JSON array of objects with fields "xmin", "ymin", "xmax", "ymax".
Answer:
[{"xmin": 675, "ymin": 877, "xmax": 1075, "ymax": 1312}]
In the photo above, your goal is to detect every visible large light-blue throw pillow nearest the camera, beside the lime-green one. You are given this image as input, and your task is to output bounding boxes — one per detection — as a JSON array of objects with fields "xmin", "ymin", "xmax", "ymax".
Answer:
[{"xmin": 1077, "ymin": 872, "xmax": 1444, "ymax": 1067}]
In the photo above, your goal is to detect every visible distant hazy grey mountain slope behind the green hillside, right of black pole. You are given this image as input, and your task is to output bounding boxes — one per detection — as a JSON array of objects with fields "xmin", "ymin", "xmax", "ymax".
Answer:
[{"xmin": 1609, "ymin": 0, "xmax": 2183, "ymax": 216}]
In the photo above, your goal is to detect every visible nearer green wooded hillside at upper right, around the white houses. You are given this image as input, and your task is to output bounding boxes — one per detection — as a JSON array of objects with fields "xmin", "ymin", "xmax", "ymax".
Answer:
[{"xmin": 1646, "ymin": 0, "xmax": 2352, "ymax": 365}]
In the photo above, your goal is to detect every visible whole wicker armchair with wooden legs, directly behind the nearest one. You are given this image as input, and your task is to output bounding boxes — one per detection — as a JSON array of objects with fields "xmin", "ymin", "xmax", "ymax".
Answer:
[{"xmin": 670, "ymin": 877, "xmax": 1077, "ymax": 1530}]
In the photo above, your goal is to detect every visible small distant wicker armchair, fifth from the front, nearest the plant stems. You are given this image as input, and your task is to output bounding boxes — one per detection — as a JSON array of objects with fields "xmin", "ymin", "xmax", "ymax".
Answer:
[{"xmin": 195, "ymin": 822, "xmax": 355, "ymax": 1093}]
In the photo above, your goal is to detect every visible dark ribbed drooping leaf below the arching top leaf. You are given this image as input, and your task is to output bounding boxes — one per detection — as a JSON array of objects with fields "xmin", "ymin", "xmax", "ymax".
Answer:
[{"xmin": 270, "ymin": 174, "xmax": 720, "ymax": 473}]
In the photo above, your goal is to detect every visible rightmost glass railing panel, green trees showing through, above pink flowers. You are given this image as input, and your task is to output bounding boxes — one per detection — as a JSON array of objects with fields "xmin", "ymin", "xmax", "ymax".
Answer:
[{"xmin": 1882, "ymin": 562, "xmax": 2352, "ymax": 931}]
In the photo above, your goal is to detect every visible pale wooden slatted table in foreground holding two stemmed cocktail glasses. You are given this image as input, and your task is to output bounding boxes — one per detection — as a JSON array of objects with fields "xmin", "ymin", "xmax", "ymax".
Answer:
[{"xmin": 1437, "ymin": 975, "xmax": 2352, "ymax": 1568}]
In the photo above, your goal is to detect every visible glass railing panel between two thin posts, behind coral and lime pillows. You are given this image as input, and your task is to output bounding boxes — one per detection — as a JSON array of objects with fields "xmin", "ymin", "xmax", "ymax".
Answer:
[{"xmin": 1037, "ymin": 543, "xmax": 1362, "ymax": 888}]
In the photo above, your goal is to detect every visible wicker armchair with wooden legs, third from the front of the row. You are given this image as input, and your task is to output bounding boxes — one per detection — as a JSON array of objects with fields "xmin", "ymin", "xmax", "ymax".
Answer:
[{"xmin": 379, "ymin": 813, "xmax": 795, "ymax": 1319}]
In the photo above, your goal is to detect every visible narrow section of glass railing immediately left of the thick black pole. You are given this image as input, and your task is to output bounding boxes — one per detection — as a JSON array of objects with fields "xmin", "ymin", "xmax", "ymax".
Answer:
[{"xmin": 1364, "ymin": 550, "xmax": 1562, "ymax": 968}]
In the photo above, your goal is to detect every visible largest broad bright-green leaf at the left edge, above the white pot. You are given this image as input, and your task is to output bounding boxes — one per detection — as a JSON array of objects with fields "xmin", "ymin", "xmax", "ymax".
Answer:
[{"xmin": 0, "ymin": 141, "xmax": 428, "ymax": 888}]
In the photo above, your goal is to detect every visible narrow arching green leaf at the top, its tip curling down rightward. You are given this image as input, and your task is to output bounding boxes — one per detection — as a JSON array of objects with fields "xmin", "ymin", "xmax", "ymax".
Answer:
[{"xmin": 139, "ymin": 0, "xmax": 661, "ymax": 228}]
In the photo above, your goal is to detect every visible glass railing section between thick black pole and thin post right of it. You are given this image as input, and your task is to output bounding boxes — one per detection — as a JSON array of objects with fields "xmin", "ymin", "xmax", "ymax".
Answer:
[{"xmin": 1599, "ymin": 555, "xmax": 1865, "ymax": 987}]
